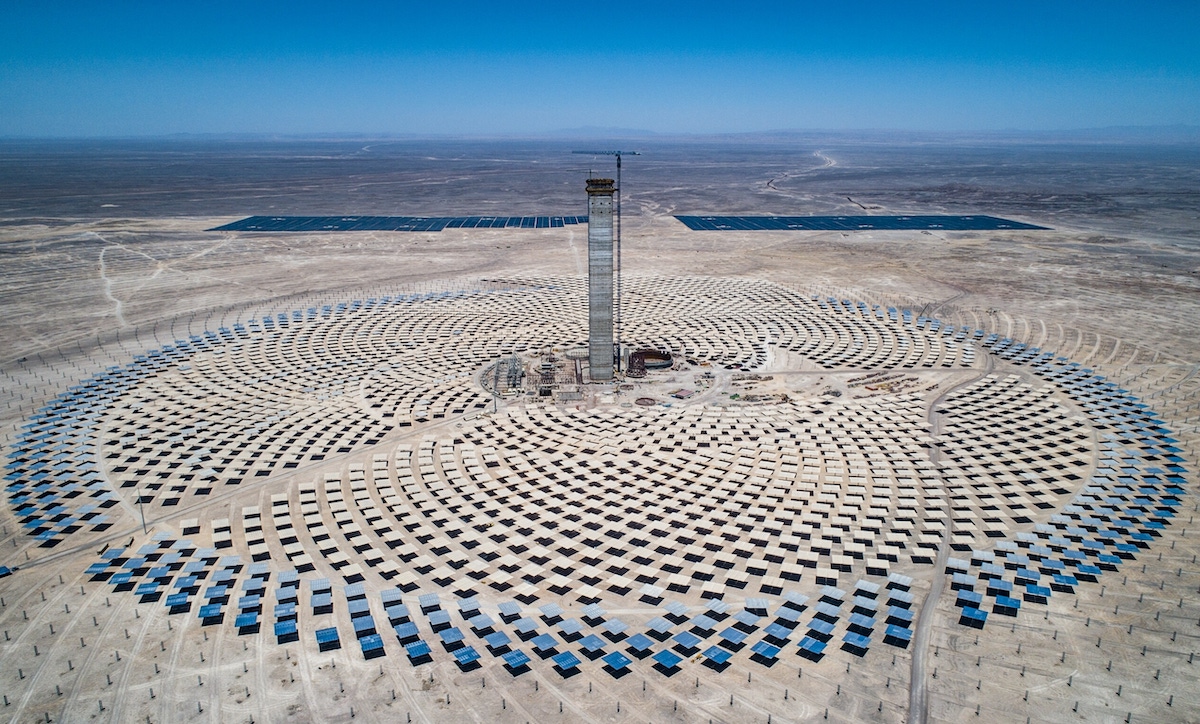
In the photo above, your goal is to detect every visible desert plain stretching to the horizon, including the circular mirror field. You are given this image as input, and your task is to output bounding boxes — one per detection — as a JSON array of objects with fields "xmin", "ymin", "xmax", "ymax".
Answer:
[{"xmin": 0, "ymin": 138, "xmax": 1200, "ymax": 722}]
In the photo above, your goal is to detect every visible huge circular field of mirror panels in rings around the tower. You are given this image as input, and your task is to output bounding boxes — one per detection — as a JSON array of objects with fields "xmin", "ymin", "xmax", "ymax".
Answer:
[{"xmin": 0, "ymin": 277, "xmax": 1183, "ymax": 720}]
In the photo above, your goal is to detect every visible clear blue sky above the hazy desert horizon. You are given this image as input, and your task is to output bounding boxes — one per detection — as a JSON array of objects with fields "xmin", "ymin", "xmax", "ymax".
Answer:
[{"xmin": 0, "ymin": 0, "xmax": 1200, "ymax": 136}]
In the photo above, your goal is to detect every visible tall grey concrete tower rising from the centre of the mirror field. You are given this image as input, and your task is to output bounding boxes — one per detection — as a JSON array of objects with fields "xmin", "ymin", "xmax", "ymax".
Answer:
[{"xmin": 588, "ymin": 179, "xmax": 613, "ymax": 382}]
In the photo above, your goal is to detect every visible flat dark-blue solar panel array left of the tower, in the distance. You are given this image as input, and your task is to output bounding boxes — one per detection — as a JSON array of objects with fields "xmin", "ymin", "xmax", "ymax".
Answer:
[{"xmin": 209, "ymin": 216, "xmax": 588, "ymax": 232}]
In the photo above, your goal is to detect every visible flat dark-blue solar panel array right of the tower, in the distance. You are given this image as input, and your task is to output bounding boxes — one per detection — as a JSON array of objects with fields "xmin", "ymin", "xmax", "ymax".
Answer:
[{"xmin": 676, "ymin": 216, "xmax": 1046, "ymax": 232}]
